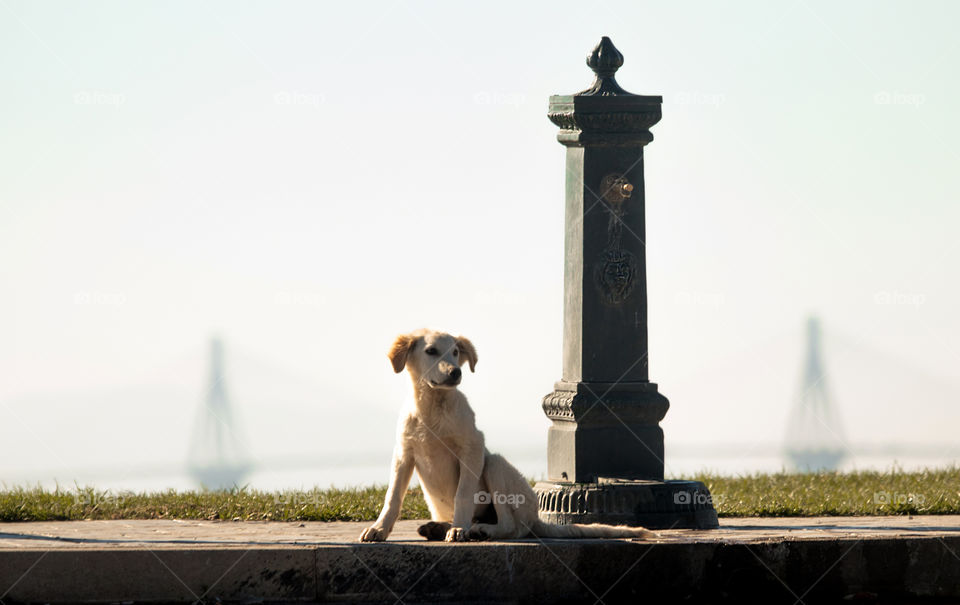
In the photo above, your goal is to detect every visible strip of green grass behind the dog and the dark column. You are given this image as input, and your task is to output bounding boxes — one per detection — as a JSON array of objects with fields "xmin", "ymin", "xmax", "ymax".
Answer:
[{"xmin": 0, "ymin": 467, "xmax": 960, "ymax": 521}]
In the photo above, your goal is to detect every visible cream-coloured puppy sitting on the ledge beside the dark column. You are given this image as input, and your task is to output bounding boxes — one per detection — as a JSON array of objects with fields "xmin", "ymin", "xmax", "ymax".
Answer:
[{"xmin": 360, "ymin": 330, "xmax": 657, "ymax": 542}]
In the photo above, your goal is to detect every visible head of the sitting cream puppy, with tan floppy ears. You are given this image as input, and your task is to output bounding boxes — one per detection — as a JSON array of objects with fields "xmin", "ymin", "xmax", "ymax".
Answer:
[{"xmin": 387, "ymin": 330, "xmax": 477, "ymax": 389}]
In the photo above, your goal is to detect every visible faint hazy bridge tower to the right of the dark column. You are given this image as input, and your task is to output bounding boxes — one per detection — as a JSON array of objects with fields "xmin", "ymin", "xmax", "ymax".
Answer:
[{"xmin": 785, "ymin": 317, "xmax": 846, "ymax": 471}]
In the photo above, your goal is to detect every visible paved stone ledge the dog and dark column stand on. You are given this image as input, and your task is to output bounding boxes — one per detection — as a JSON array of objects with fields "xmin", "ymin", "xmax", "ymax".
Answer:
[{"xmin": 0, "ymin": 517, "xmax": 960, "ymax": 604}]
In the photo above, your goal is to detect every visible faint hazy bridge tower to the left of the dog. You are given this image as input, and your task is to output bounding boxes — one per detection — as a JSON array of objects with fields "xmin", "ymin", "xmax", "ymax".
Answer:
[{"xmin": 187, "ymin": 338, "xmax": 252, "ymax": 489}]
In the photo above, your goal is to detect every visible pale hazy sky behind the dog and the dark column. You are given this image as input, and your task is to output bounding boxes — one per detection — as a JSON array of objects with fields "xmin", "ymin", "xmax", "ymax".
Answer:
[{"xmin": 0, "ymin": 0, "xmax": 960, "ymax": 488}]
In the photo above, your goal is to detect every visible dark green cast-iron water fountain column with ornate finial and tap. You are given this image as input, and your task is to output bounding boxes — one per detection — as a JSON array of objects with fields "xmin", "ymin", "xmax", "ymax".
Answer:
[{"xmin": 537, "ymin": 37, "xmax": 716, "ymax": 527}]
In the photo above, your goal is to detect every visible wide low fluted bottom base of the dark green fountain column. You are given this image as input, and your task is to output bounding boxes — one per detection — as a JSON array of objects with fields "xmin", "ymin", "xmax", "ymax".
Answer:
[{"xmin": 534, "ymin": 478, "xmax": 719, "ymax": 529}]
